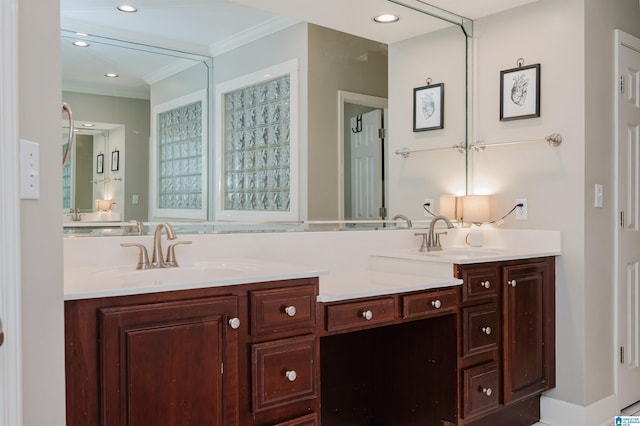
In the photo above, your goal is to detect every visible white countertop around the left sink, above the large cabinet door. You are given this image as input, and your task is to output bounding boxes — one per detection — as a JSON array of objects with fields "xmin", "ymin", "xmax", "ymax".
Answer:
[{"xmin": 64, "ymin": 259, "xmax": 327, "ymax": 300}]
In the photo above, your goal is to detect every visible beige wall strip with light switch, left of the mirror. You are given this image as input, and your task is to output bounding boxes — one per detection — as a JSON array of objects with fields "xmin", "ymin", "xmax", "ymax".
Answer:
[{"xmin": 16, "ymin": 0, "xmax": 65, "ymax": 426}]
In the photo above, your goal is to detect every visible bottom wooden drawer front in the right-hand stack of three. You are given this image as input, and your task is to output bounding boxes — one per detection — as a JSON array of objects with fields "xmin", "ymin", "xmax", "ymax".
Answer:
[{"xmin": 462, "ymin": 362, "xmax": 500, "ymax": 417}]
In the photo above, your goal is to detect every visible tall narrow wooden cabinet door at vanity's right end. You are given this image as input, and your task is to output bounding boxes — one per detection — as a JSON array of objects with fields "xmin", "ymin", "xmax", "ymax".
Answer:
[{"xmin": 503, "ymin": 261, "xmax": 555, "ymax": 404}]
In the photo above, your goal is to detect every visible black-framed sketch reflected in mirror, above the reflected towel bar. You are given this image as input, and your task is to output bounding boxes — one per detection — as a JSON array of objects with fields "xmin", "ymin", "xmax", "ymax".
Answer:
[{"xmin": 413, "ymin": 83, "xmax": 444, "ymax": 132}]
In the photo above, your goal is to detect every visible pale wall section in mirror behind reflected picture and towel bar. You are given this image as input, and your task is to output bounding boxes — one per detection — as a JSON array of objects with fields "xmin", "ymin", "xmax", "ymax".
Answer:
[{"xmin": 388, "ymin": 27, "xmax": 466, "ymax": 218}]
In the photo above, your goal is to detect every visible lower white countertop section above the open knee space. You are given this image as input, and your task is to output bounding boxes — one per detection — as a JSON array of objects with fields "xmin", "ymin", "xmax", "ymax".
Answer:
[{"xmin": 317, "ymin": 270, "xmax": 462, "ymax": 302}]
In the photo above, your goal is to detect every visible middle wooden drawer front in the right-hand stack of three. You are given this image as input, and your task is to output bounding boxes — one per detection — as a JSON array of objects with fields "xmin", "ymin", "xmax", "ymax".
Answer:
[{"xmin": 462, "ymin": 303, "xmax": 500, "ymax": 356}]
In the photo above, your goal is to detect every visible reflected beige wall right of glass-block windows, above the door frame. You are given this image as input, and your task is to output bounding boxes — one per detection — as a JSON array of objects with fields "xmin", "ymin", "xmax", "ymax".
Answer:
[{"xmin": 307, "ymin": 24, "xmax": 388, "ymax": 220}]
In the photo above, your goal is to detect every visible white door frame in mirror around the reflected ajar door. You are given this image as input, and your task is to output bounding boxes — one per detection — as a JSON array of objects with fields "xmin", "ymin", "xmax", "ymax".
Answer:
[{"xmin": 337, "ymin": 90, "xmax": 389, "ymax": 220}]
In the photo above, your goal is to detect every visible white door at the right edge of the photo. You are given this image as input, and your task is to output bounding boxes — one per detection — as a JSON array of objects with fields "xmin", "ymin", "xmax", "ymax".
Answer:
[{"xmin": 616, "ymin": 32, "xmax": 640, "ymax": 408}]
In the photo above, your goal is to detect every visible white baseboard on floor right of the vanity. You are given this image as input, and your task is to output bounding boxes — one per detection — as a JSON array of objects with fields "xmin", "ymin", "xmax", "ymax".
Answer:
[{"xmin": 540, "ymin": 395, "xmax": 619, "ymax": 426}]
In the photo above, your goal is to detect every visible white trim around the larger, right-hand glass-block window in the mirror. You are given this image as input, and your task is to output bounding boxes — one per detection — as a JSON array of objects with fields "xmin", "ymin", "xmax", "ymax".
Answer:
[{"xmin": 213, "ymin": 59, "xmax": 301, "ymax": 221}]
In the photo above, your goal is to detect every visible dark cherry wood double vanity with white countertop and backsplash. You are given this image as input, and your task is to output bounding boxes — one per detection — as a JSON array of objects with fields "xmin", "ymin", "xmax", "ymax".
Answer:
[{"xmin": 65, "ymin": 229, "xmax": 560, "ymax": 426}]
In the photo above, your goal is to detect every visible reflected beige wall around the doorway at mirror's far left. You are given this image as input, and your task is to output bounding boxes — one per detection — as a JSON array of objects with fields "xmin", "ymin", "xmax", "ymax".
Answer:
[{"xmin": 62, "ymin": 92, "xmax": 151, "ymax": 221}]
